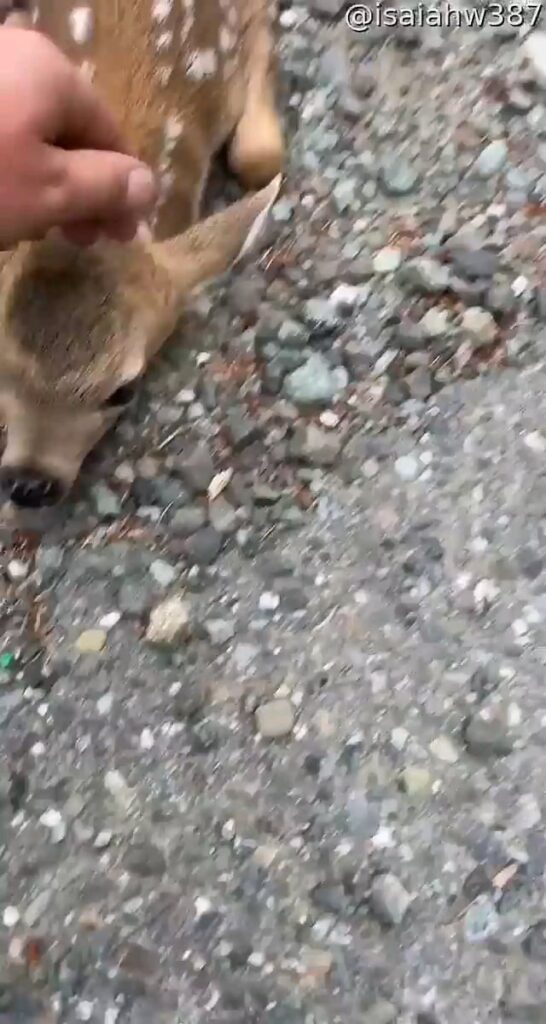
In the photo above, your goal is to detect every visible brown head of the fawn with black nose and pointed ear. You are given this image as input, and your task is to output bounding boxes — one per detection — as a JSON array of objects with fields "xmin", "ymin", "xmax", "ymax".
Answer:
[{"xmin": 0, "ymin": 176, "xmax": 281, "ymax": 508}]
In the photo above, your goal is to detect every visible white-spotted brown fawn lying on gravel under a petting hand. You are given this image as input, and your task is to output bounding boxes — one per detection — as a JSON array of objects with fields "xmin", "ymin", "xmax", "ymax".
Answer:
[{"xmin": 0, "ymin": 0, "xmax": 284, "ymax": 509}]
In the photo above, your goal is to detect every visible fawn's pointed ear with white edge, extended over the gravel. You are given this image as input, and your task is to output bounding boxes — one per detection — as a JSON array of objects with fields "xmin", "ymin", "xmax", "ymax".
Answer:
[{"xmin": 152, "ymin": 174, "xmax": 282, "ymax": 298}]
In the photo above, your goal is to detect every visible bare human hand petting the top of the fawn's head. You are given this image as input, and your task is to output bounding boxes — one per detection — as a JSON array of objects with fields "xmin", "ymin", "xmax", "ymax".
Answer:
[{"xmin": 0, "ymin": 26, "xmax": 156, "ymax": 249}]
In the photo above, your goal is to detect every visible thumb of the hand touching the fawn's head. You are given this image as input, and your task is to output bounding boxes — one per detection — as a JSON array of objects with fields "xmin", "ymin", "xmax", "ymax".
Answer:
[{"xmin": 47, "ymin": 150, "xmax": 157, "ymax": 225}]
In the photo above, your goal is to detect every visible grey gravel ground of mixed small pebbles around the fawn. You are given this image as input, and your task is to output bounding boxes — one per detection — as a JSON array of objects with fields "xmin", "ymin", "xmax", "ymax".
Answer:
[{"xmin": 0, "ymin": 8, "xmax": 546, "ymax": 1024}]
